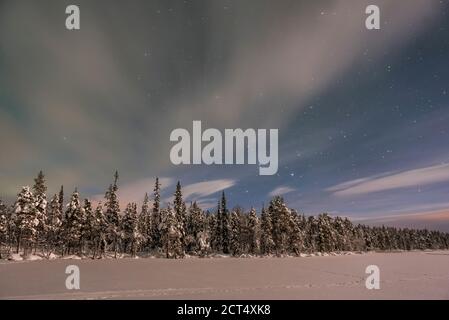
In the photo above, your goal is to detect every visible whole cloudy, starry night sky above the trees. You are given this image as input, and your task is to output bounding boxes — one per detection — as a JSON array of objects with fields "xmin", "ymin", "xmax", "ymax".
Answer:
[{"xmin": 0, "ymin": 0, "xmax": 449, "ymax": 230}]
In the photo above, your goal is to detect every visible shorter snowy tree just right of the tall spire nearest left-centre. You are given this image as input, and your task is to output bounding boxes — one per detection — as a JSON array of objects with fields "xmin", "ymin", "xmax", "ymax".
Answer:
[{"xmin": 122, "ymin": 203, "xmax": 143, "ymax": 257}]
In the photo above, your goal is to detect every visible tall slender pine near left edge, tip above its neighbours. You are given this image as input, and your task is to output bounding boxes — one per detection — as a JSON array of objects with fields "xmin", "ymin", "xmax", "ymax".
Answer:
[{"xmin": 33, "ymin": 171, "xmax": 47, "ymax": 249}]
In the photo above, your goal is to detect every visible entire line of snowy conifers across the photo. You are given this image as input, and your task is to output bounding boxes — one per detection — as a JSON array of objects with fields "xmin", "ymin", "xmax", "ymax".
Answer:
[{"xmin": 0, "ymin": 172, "xmax": 449, "ymax": 258}]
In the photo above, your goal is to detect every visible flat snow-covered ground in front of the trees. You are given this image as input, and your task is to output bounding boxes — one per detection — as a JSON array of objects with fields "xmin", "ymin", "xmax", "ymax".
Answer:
[{"xmin": 0, "ymin": 251, "xmax": 449, "ymax": 299}]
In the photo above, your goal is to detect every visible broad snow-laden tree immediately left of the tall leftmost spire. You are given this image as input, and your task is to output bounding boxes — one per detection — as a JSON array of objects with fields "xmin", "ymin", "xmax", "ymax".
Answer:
[{"xmin": 14, "ymin": 186, "xmax": 39, "ymax": 256}]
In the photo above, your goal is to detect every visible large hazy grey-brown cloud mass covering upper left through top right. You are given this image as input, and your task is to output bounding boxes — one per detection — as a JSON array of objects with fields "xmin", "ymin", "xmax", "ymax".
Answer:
[{"xmin": 0, "ymin": 0, "xmax": 439, "ymax": 200}]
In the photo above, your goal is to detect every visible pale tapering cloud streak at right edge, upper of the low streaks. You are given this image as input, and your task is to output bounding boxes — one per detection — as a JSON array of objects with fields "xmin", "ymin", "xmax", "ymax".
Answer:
[{"xmin": 326, "ymin": 164, "xmax": 449, "ymax": 196}]
